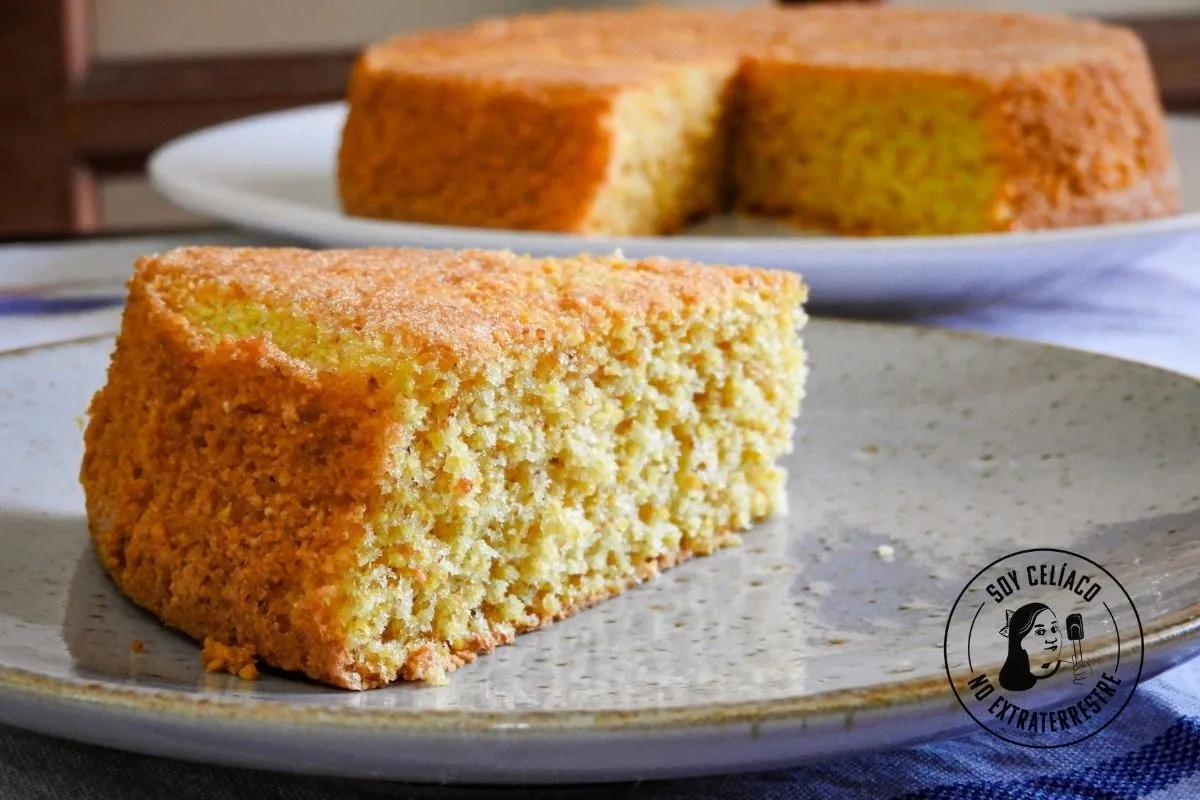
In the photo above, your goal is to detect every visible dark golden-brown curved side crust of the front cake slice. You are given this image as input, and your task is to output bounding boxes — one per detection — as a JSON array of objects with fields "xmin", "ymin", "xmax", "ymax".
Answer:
[{"xmin": 80, "ymin": 263, "xmax": 398, "ymax": 686}]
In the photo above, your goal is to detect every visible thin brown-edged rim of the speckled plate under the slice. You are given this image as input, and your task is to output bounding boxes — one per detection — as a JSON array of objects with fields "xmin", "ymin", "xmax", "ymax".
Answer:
[{"xmin": 9, "ymin": 314, "xmax": 1200, "ymax": 738}]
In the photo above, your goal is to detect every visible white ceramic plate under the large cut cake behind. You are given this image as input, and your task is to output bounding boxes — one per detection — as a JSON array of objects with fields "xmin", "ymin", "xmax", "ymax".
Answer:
[{"xmin": 150, "ymin": 103, "xmax": 1200, "ymax": 308}]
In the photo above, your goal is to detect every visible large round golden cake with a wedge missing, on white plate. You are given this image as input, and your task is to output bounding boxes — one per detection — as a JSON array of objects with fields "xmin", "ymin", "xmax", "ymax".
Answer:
[{"xmin": 338, "ymin": 6, "xmax": 1178, "ymax": 235}]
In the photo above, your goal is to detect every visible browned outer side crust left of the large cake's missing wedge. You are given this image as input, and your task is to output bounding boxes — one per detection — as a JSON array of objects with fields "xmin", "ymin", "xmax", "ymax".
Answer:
[{"xmin": 338, "ymin": 56, "xmax": 612, "ymax": 230}]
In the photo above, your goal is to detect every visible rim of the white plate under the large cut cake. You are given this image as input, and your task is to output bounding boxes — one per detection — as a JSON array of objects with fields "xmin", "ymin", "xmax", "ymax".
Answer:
[{"xmin": 148, "ymin": 101, "xmax": 1200, "ymax": 256}]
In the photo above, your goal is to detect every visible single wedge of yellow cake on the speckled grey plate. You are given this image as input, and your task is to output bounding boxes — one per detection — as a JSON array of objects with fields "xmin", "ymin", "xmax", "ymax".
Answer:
[{"xmin": 82, "ymin": 248, "xmax": 805, "ymax": 688}]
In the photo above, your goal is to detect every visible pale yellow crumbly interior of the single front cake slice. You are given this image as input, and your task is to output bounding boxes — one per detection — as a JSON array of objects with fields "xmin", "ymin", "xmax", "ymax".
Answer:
[{"xmin": 150, "ymin": 248, "xmax": 805, "ymax": 685}]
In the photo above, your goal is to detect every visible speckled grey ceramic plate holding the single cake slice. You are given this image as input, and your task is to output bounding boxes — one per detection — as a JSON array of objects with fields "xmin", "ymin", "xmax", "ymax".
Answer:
[{"xmin": 0, "ymin": 320, "xmax": 1200, "ymax": 781}]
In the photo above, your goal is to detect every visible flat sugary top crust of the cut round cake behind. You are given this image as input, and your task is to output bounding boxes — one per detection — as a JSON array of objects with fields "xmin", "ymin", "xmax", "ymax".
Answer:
[{"xmin": 362, "ymin": 5, "xmax": 1141, "ymax": 88}]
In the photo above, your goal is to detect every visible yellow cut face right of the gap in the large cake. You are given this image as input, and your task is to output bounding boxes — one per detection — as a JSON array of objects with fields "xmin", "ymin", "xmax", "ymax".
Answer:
[{"xmin": 732, "ymin": 64, "xmax": 1003, "ymax": 234}]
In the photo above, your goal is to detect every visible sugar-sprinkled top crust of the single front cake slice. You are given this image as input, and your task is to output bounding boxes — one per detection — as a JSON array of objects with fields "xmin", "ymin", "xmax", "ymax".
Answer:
[{"xmin": 133, "ymin": 247, "xmax": 805, "ymax": 360}]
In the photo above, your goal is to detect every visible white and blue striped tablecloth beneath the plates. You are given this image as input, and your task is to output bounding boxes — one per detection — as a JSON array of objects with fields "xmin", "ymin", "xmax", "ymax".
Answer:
[{"xmin": 0, "ymin": 231, "xmax": 1200, "ymax": 800}]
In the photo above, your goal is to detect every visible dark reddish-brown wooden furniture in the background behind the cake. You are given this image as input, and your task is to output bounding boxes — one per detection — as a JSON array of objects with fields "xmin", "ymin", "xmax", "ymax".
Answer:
[{"xmin": 0, "ymin": 0, "xmax": 1200, "ymax": 237}]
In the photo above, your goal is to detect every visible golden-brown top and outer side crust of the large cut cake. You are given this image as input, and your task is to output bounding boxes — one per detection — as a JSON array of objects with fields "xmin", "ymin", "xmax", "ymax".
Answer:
[{"xmin": 338, "ymin": 6, "xmax": 1178, "ymax": 233}]
